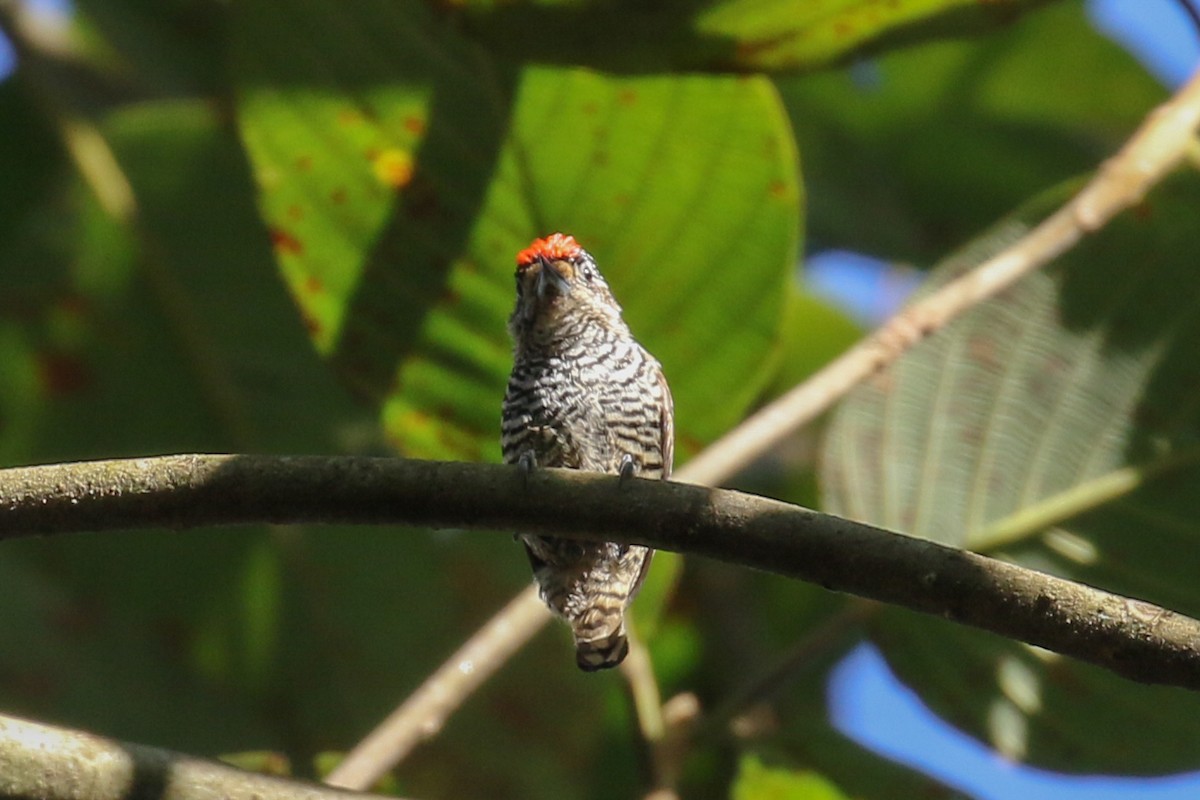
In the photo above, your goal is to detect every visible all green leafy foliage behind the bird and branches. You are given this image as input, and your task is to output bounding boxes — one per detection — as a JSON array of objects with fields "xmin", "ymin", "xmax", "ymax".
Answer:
[{"xmin": 0, "ymin": 0, "xmax": 1200, "ymax": 800}]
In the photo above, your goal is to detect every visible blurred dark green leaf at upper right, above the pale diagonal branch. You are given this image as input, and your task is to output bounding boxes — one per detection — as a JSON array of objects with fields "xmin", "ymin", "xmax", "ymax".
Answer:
[{"xmin": 776, "ymin": 0, "xmax": 1165, "ymax": 265}]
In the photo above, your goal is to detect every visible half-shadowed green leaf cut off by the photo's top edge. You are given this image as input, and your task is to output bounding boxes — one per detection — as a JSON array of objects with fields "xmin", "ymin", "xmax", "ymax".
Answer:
[{"xmin": 468, "ymin": 0, "xmax": 1048, "ymax": 72}]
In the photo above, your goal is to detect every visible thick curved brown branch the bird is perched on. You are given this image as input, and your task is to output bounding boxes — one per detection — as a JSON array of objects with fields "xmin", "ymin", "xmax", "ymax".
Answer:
[{"xmin": 0, "ymin": 456, "xmax": 1200, "ymax": 690}]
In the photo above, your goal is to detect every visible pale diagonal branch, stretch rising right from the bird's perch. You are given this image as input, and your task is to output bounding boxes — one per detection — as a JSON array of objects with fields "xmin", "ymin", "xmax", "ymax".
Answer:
[{"xmin": 688, "ymin": 65, "xmax": 1200, "ymax": 485}]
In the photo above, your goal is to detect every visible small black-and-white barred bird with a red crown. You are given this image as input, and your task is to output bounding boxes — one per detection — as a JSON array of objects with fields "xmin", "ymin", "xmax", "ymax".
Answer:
[{"xmin": 500, "ymin": 234, "xmax": 674, "ymax": 672}]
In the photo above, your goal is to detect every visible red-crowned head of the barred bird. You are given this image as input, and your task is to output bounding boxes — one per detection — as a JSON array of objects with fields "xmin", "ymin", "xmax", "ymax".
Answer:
[{"xmin": 509, "ymin": 234, "xmax": 624, "ymax": 341}]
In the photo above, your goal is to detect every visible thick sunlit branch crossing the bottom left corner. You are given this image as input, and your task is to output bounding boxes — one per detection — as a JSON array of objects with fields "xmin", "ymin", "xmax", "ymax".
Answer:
[{"xmin": 0, "ymin": 716, "xmax": 403, "ymax": 800}]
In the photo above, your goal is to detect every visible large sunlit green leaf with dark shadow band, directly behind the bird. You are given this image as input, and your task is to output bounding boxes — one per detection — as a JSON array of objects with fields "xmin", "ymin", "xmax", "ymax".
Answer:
[{"xmin": 236, "ymin": 2, "xmax": 799, "ymax": 459}]
